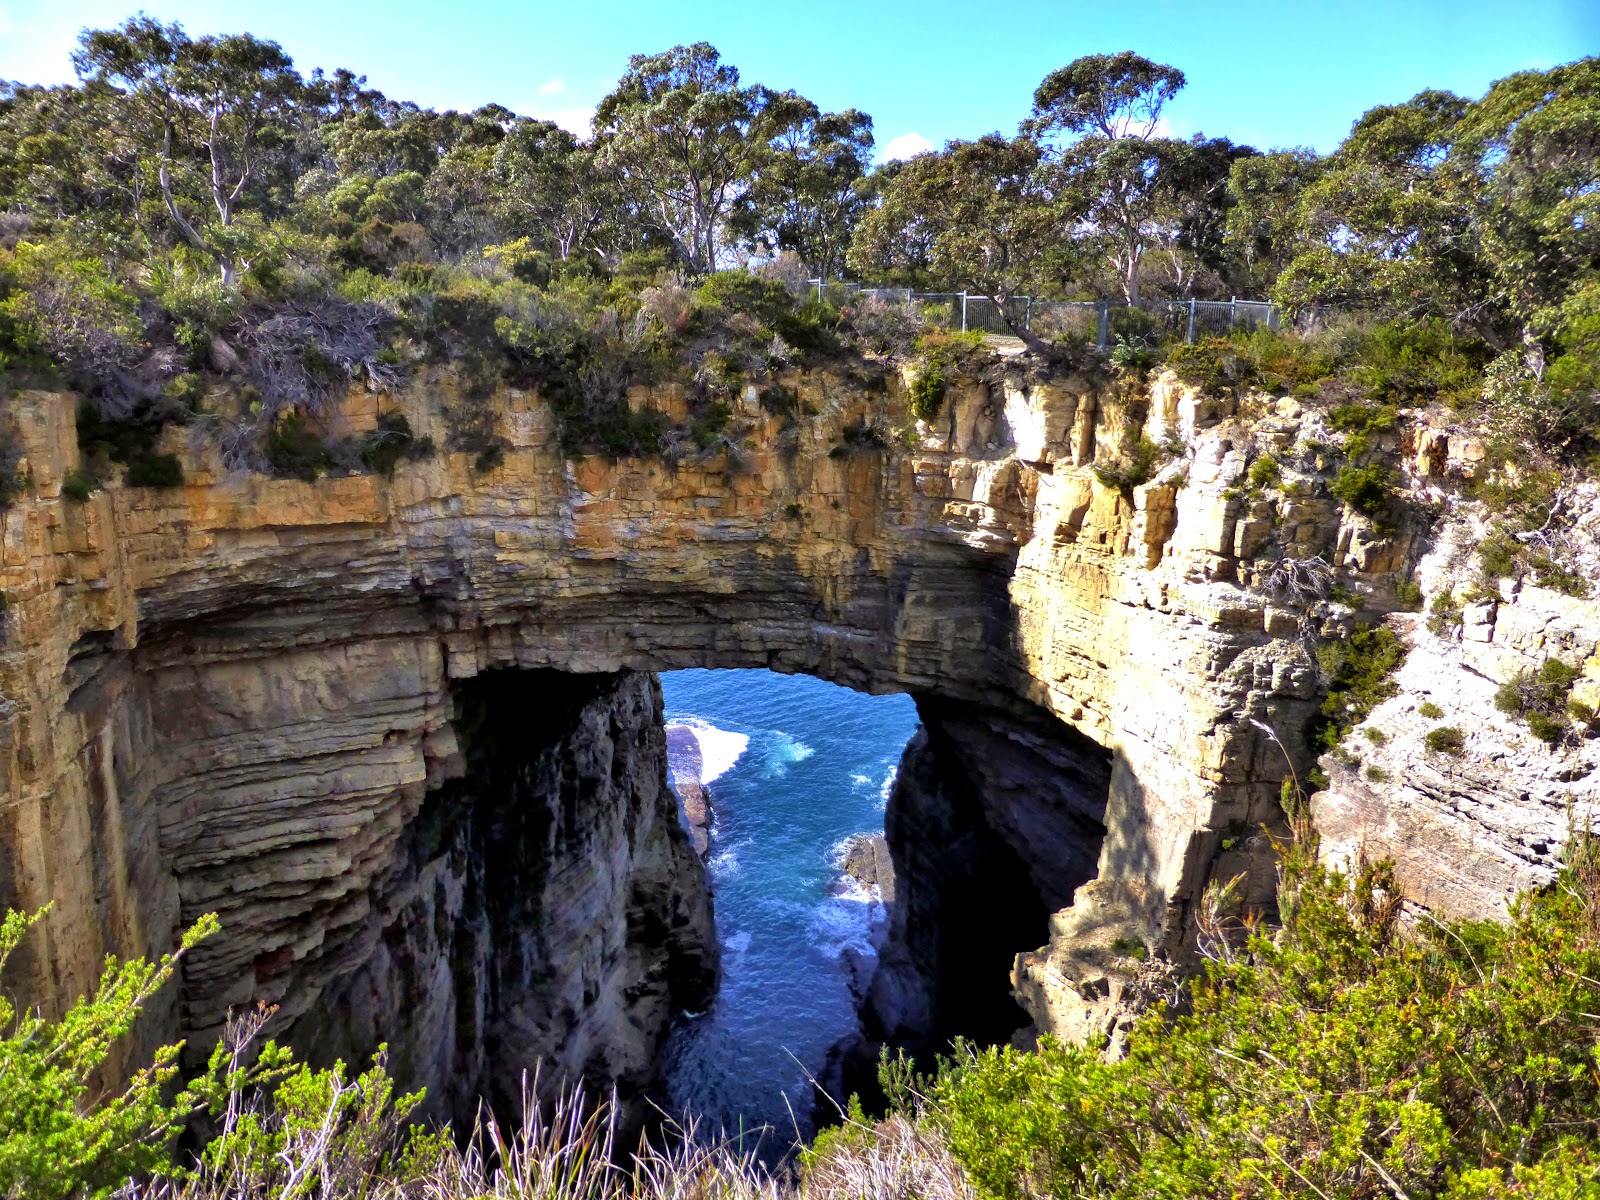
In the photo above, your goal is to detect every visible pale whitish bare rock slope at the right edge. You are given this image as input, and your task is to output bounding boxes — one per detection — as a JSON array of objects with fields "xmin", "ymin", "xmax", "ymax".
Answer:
[{"xmin": 1312, "ymin": 562, "xmax": 1600, "ymax": 920}]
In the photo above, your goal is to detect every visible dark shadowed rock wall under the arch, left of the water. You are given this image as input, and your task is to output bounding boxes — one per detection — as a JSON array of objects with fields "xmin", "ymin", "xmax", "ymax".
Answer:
[{"xmin": 285, "ymin": 670, "xmax": 717, "ymax": 1122}]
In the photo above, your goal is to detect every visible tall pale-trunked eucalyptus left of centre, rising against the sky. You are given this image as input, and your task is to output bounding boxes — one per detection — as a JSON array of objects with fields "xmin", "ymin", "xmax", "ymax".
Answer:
[{"xmin": 595, "ymin": 42, "xmax": 814, "ymax": 272}]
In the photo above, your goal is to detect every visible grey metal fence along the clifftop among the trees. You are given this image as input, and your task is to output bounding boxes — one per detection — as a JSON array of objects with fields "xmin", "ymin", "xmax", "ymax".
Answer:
[{"xmin": 790, "ymin": 278, "xmax": 1283, "ymax": 350}]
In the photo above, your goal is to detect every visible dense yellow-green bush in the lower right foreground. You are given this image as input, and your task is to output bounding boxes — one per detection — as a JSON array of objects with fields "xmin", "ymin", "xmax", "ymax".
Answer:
[{"xmin": 931, "ymin": 843, "xmax": 1600, "ymax": 1200}]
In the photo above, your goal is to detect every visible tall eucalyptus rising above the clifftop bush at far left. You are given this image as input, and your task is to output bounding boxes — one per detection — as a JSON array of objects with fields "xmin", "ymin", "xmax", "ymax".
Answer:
[{"xmin": 74, "ymin": 14, "xmax": 325, "ymax": 285}]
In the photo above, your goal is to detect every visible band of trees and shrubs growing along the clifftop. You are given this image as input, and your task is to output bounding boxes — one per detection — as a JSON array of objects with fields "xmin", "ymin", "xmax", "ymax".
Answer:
[{"xmin": 0, "ymin": 25, "xmax": 1600, "ymax": 499}]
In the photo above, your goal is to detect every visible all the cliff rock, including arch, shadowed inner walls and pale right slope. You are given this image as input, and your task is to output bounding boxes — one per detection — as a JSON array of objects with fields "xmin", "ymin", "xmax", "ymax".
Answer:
[{"xmin": 0, "ymin": 362, "xmax": 1600, "ymax": 1114}]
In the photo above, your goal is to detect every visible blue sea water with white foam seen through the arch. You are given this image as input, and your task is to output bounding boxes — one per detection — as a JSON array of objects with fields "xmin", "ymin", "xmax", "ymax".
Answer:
[{"xmin": 661, "ymin": 670, "xmax": 917, "ymax": 1150}]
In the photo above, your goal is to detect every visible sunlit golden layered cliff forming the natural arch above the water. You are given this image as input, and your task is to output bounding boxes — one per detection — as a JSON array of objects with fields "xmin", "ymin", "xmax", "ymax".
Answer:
[{"xmin": 0, "ymin": 350, "xmax": 1592, "ymax": 1069}]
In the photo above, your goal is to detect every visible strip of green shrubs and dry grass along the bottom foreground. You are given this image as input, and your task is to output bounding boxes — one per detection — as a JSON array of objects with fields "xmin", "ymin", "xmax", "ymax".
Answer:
[{"xmin": 9, "ymin": 824, "xmax": 1600, "ymax": 1200}]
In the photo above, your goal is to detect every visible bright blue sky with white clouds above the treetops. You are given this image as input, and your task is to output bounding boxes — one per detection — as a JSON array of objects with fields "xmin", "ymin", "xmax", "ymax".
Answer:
[{"xmin": 0, "ymin": 0, "xmax": 1600, "ymax": 152}]
